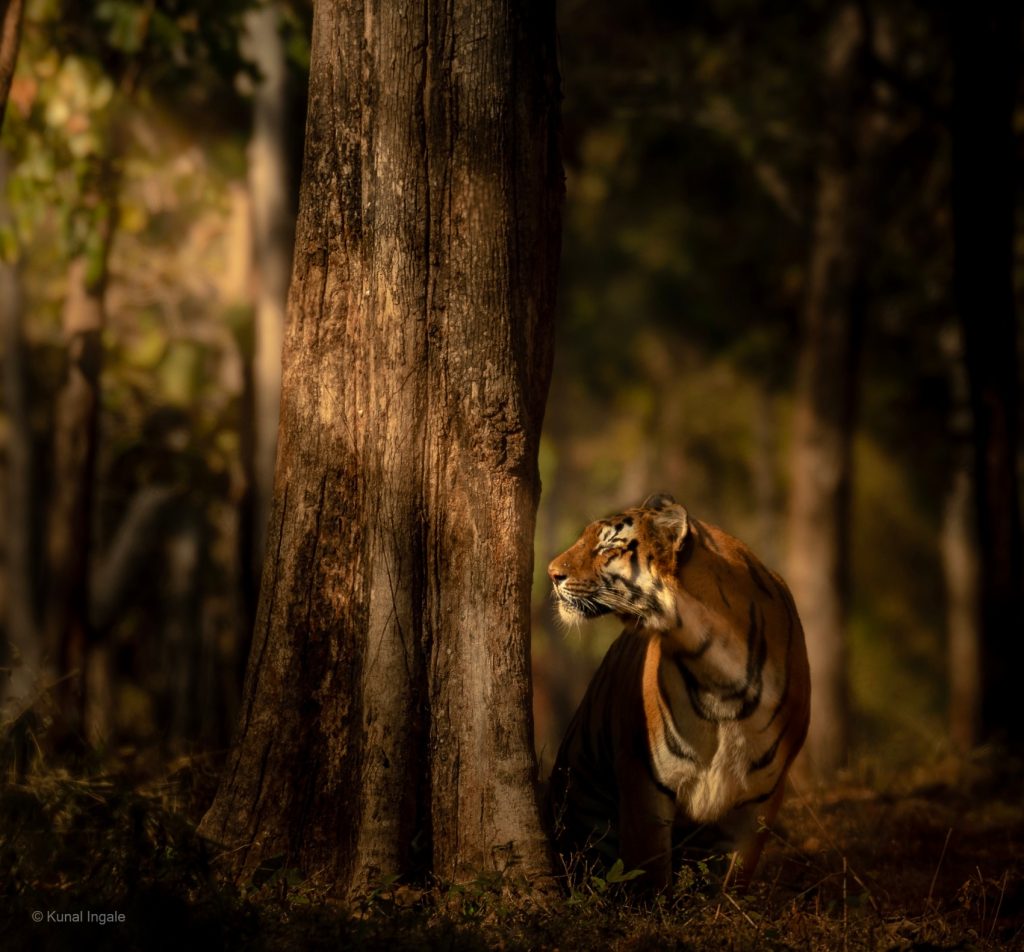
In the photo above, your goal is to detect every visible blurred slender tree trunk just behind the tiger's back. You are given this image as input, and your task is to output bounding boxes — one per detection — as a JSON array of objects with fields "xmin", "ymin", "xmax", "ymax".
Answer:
[{"xmin": 787, "ymin": 5, "xmax": 863, "ymax": 777}]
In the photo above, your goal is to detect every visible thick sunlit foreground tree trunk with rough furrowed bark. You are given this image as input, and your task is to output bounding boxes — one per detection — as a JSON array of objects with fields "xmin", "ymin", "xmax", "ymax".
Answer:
[{"xmin": 201, "ymin": 0, "xmax": 561, "ymax": 892}]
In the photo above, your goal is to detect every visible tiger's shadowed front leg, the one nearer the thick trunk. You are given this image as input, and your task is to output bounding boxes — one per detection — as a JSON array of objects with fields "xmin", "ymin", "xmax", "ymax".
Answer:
[{"xmin": 618, "ymin": 762, "xmax": 676, "ymax": 892}]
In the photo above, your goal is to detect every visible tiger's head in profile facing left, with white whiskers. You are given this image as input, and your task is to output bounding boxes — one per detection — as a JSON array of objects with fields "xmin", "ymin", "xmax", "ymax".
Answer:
[{"xmin": 548, "ymin": 493, "xmax": 691, "ymax": 631}]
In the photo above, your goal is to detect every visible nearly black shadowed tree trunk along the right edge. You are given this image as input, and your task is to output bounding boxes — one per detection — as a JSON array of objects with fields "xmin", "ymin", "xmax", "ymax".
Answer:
[{"xmin": 952, "ymin": 4, "xmax": 1024, "ymax": 742}]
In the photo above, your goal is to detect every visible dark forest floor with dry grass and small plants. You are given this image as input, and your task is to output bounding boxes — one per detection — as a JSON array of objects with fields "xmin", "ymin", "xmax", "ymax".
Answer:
[{"xmin": 0, "ymin": 737, "xmax": 1024, "ymax": 952}]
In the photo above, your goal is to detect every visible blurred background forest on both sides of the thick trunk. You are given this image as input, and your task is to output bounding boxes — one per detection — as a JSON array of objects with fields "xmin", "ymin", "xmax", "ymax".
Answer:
[{"xmin": 0, "ymin": 0, "xmax": 1024, "ymax": 786}]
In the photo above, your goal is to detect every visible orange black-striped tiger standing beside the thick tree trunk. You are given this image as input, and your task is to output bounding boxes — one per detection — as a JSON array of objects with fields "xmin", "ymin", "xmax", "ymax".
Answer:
[{"xmin": 547, "ymin": 493, "xmax": 810, "ymax": 891}]
